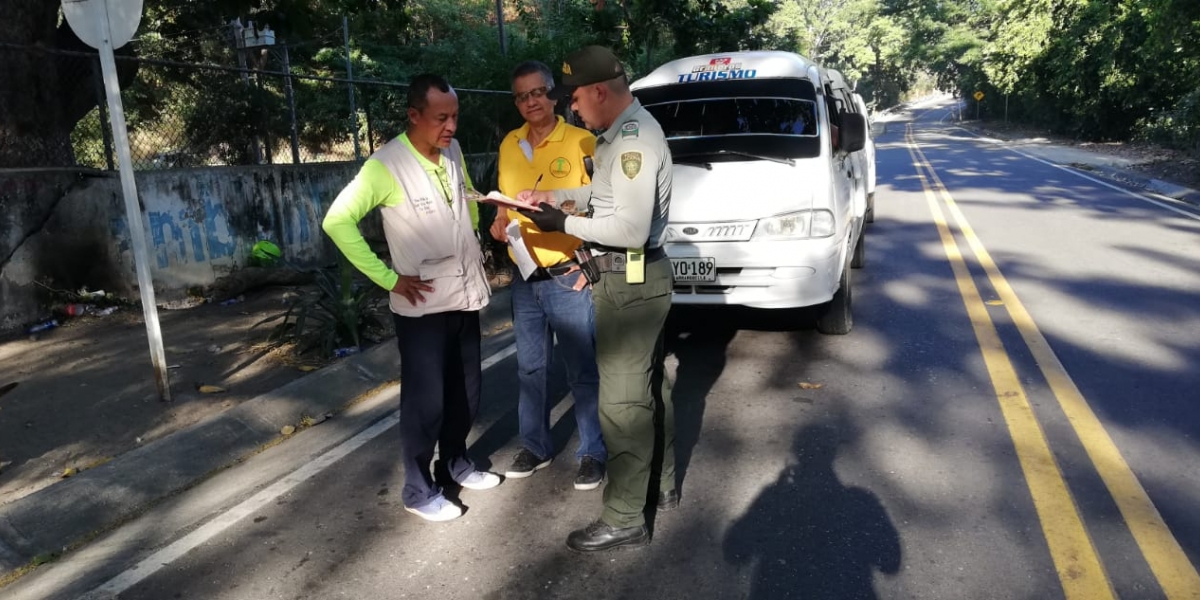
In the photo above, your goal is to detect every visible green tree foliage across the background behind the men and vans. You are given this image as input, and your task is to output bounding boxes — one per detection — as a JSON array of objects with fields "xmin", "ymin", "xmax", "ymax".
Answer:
[{"xmin": 42, "ymin": 0, "xmax": 1200, "ymax": 162}]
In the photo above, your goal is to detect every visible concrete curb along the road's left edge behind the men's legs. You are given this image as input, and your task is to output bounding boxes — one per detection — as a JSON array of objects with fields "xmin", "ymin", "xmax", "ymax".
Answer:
[{"xmin": 0, "ymin": 289, "xmax": 512, "ymax": 580}]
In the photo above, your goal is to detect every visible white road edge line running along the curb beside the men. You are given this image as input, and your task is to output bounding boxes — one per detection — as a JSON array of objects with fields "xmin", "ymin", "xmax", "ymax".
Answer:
[{"xmin": 79, "ymin": 344, "xmax": 517, "ymax": 600}]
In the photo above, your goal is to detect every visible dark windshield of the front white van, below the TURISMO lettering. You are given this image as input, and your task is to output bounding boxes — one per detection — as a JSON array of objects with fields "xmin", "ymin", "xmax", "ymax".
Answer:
[{"xmin": 635, "ymin": 79, "xmax": 821, "ymax": 162}]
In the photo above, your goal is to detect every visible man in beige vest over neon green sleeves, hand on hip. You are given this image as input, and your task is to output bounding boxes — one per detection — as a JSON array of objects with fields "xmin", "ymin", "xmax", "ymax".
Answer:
[{"xmin": 323, "ymin": 74, "xmax": 500, "ymax": 521}]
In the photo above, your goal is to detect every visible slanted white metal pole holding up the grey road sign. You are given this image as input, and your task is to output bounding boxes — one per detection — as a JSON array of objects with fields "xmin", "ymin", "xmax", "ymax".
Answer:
[{"xmin": 100, "ymin": 36, "xmax": 170, "ymax": 402}]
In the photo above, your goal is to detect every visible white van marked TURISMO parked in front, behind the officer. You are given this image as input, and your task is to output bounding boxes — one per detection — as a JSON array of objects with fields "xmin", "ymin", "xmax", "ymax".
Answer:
[{"xmin": 632, "ymin": 52, "xmax": 866, "ymax": 334}]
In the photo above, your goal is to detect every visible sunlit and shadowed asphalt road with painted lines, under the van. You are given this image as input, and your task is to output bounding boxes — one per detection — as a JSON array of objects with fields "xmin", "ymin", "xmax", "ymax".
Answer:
[{"xmin": 5, "ymin": 99, "xmax": 1200, "ymax": 600}]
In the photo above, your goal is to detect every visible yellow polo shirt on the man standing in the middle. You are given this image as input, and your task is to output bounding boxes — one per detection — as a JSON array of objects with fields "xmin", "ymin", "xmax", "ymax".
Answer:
[{"xmin": 497, "ymin": 116, "xmax": 596, "ymax": 266}]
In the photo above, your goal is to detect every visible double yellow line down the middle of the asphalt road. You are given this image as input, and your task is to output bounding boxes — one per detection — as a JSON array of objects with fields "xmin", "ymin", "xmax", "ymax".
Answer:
[{"xmin": 905, "ymin": 124, "xmax": 1200, "ymax": 600}]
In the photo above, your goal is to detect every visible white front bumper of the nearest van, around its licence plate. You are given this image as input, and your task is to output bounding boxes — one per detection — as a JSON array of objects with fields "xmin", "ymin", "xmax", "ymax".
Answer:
[{"xmin": 664, "ymin": 238, "xmax": 845, "ymax": 308}]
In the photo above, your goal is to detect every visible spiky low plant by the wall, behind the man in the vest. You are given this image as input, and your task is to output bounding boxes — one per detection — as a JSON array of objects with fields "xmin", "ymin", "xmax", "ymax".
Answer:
[{"xmin": 254, "ymin": 253, "xmax": 386, "ymax": 355}]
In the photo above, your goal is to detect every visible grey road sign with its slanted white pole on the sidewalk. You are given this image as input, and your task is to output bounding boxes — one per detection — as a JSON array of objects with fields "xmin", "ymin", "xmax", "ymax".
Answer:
[{"xmin": 62, "ymin": 0, "xmax": 170, "ymax": 402}]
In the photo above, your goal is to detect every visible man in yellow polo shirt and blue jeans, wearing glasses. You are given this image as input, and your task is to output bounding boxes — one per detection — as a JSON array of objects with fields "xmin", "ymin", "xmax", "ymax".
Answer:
[{"xmin": 491, "ymin": 61, "xmax": 608, "ymax": 490}]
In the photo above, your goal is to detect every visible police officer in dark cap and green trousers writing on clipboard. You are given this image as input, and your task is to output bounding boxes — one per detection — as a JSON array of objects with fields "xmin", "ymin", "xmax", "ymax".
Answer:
[{"xmin": 518, "ymin": 46, "xmax": 679, "ymax": 552}]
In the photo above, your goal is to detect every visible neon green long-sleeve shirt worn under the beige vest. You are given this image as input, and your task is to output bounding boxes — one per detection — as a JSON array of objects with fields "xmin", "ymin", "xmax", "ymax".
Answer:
[{"xmin": 322, "ymin": 133, "xmax": 479, "ymax": 290}]
